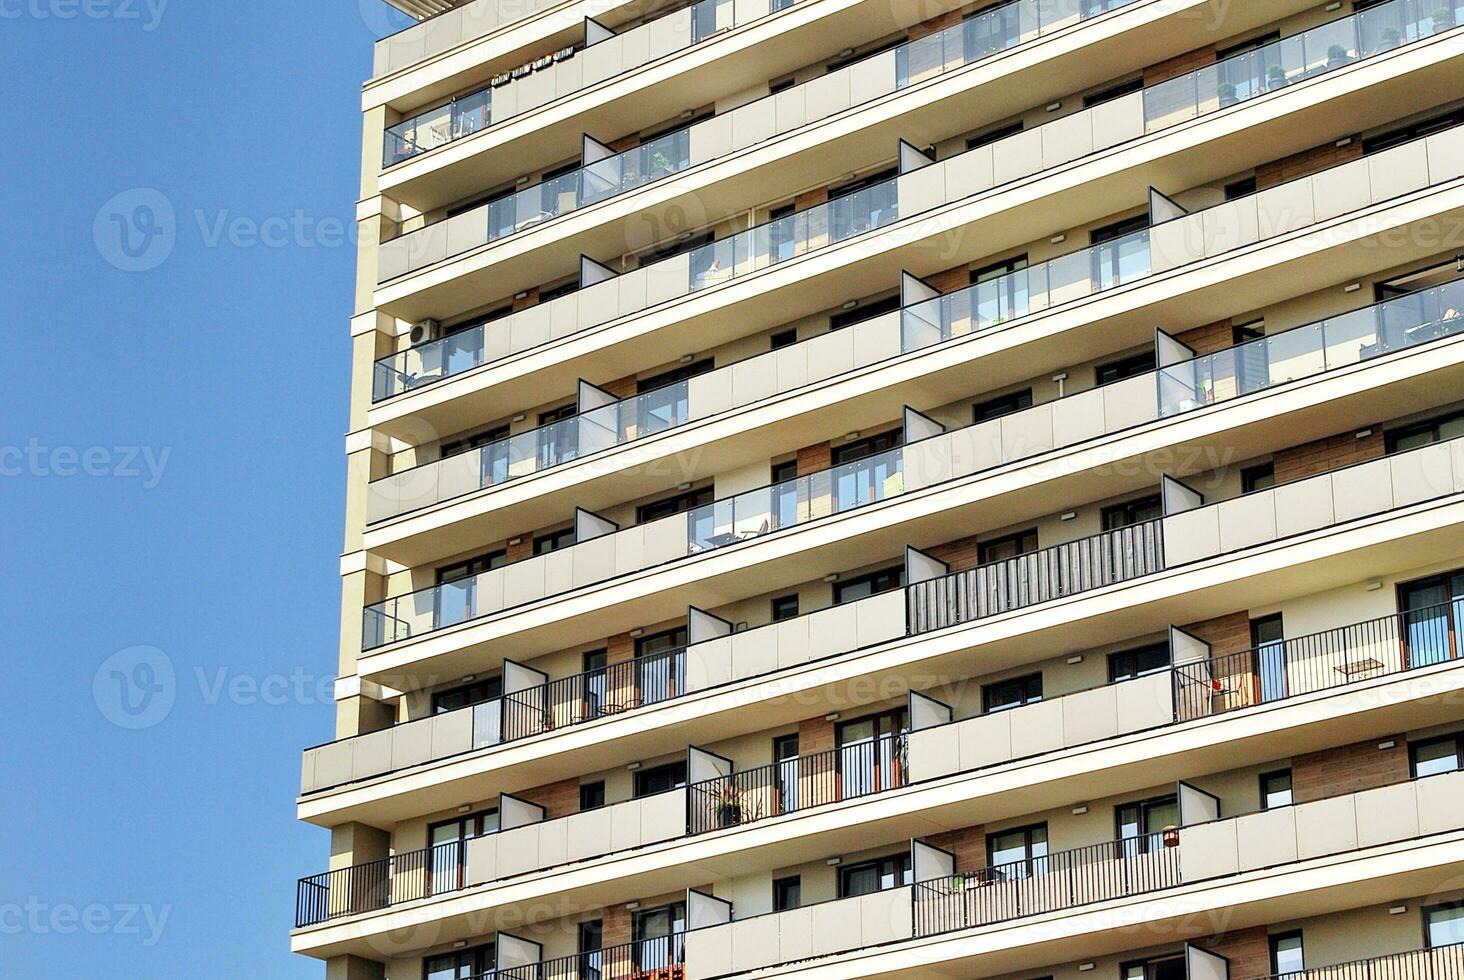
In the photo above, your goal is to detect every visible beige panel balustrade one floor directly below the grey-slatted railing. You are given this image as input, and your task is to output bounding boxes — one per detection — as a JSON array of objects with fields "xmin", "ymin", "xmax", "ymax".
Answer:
[{"xmin": 906, "ymin": 671, "xmax": 1174, "ymax": 782}]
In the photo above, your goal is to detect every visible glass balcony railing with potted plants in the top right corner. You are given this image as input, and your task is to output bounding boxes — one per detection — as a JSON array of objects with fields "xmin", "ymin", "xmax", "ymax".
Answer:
[{"xmin": 1143, "ymin": 0, "xmax": 1464, "ymax": 132}]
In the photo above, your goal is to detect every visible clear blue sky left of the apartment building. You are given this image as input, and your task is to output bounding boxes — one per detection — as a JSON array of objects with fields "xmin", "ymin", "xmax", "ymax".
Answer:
[{"xmin": 0, "ymin": 0, "xmax": 412, "ymax": 980}]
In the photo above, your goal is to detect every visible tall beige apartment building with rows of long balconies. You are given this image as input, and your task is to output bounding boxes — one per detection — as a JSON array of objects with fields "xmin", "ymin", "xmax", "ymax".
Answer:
[{"xmin": 291, "ymin": 0, "xmax": 1464, "ymax": 980}]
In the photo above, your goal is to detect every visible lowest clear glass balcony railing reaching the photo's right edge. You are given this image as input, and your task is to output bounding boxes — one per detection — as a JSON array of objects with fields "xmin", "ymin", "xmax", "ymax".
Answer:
[{"xmin": 1158, "ymin": 280, "xmax": 1464, "ymax": 417}]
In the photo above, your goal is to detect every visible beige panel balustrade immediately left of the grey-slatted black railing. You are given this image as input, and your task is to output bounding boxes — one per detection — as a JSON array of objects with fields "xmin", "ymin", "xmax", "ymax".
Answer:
[{"xmin": 687, "ymin": 589, "xmax": 906, "ymax": 693}]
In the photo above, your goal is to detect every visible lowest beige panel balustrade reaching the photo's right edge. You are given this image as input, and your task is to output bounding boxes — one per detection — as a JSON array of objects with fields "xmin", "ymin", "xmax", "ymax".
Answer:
[{"xmin": 1180, "ymin": 772, "xmax": 1464, "ymax": 883}]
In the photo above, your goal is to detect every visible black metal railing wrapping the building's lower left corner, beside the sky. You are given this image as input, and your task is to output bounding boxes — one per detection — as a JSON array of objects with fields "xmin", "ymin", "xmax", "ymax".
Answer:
[{"xmin": 294, "ymin": 841, "xmax": 468, "ymax": 929}]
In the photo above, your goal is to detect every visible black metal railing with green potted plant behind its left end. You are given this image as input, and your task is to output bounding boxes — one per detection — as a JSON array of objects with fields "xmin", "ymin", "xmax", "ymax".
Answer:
[{"xmin": 687, "ymin": 735, "xmax": 908, "ymax": 835}]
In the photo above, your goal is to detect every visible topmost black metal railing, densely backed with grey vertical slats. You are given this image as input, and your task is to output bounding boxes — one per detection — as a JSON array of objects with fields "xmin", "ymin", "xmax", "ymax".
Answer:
[{"xmin": 908, "ymin": 520, "xmax": 1164, "ymax": 634}]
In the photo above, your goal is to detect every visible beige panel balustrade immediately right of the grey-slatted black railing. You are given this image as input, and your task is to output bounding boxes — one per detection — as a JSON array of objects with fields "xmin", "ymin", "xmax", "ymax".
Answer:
[{"xmin": 1164, "ymin": 439, "xmax": 1464, "ymax": 568}]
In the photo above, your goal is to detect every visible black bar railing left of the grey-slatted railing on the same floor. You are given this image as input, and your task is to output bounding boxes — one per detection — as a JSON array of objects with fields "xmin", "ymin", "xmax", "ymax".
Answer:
[{"xmin": 504, "ymin": 647, "xmax": 687, "ymax": 741}]
